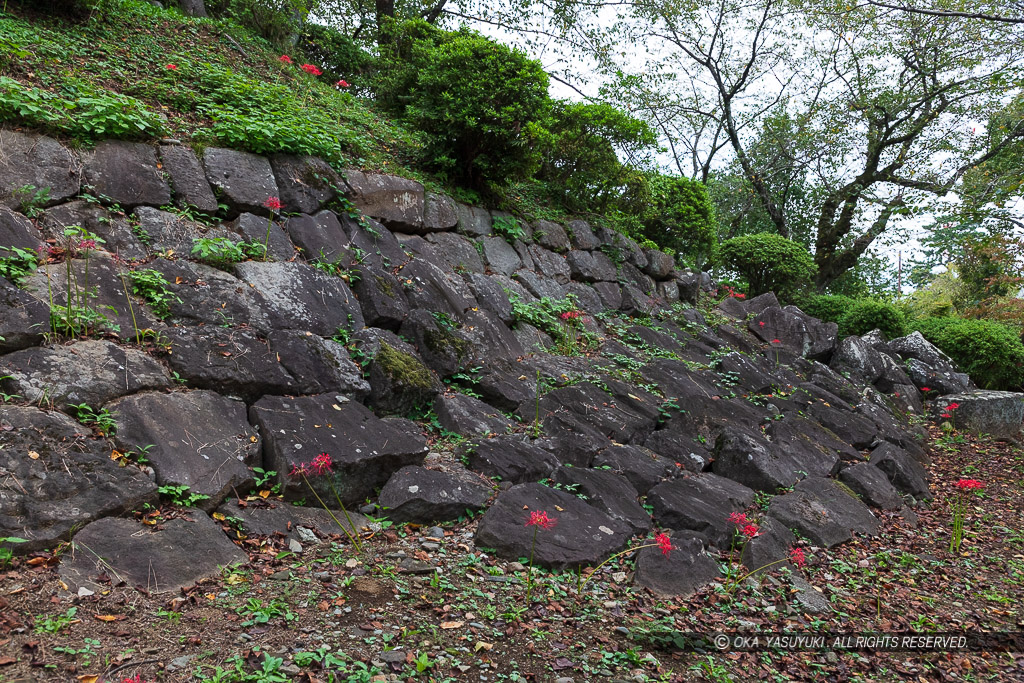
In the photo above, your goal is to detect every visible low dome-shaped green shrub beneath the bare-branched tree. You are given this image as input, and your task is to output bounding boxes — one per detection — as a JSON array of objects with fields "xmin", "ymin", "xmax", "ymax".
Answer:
[{"xmin": 718, "ymin": 232, "xmax": 817, "ymax": 298}]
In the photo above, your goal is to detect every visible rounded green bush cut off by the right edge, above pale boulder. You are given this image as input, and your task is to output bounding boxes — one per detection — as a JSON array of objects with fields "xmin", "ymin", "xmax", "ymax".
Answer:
[{"xmin": 914, "ymin": 317, "xmax": 1024, "ymax": 391}]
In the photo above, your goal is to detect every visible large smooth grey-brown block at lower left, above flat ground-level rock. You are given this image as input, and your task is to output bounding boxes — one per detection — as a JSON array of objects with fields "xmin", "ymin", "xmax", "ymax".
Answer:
[{"xmin": 109, "ymin": 391, "xmax": 260, "ymax": 510}]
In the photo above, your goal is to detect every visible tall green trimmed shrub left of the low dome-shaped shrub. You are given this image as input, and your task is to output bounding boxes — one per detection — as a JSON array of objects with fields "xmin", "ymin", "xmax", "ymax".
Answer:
[{"xmin": 642, "ymin": 175, "xmax": 718, "ymax": 268}]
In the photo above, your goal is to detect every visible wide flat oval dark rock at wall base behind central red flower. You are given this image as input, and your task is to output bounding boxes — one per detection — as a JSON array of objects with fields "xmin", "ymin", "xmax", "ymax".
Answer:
[{"xmin": 476, "ymin": 483, "xmax": 632, "ymax": 569}]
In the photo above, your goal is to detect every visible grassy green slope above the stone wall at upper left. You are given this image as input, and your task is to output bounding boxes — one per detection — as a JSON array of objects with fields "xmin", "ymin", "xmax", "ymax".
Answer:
[{"xmin": 0, "ymin": 0, "xmax": 426, "ymax": 179}]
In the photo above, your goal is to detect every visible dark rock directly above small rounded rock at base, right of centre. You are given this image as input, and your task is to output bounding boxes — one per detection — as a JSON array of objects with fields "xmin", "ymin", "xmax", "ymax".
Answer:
[{"xmin": 647, "ymin": 474, "xmax": 754, "ymax": 548}]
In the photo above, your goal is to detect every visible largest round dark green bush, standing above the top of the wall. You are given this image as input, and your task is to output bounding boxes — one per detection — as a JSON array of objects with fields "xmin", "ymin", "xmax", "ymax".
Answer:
[{"xmin": 406, "ymin": 31, "xmax": 551, "ymax": 187}]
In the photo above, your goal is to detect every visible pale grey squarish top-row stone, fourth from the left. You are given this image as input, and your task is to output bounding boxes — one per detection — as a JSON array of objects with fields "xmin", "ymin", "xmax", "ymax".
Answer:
[{"xmin": 203, "ymin": 147, "xmax": 280, "ymax": 216}]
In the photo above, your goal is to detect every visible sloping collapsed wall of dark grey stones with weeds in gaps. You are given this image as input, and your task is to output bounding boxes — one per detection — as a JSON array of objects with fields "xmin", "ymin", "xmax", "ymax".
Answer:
[{"xmin": 0, "ymin": 130, "xmax": 1007, "ymax": 593}]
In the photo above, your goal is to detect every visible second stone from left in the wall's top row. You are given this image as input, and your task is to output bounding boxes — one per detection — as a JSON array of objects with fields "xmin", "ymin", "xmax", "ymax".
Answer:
[{"xmin": 83, "ymin": 140, "xmax": 171, "ymax": 210}]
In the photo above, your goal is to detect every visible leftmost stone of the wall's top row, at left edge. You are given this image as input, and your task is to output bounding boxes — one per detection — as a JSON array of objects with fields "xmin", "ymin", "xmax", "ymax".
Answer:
[{"xmin": 0, "ymin": 128, "xmax": 82, "ymax": 209}]
